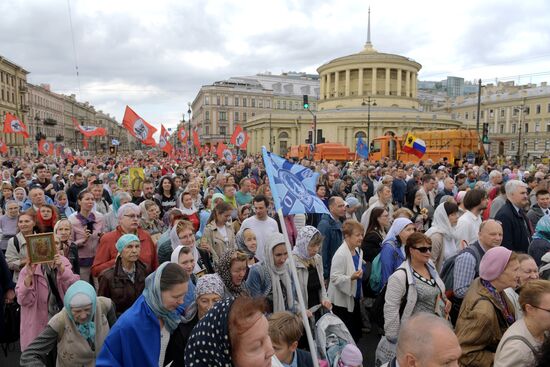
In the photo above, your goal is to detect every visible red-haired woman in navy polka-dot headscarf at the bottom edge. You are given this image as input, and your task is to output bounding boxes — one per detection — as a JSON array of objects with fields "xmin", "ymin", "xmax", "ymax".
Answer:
[{"xmin": 185, "ymin": 297, "xmax": 280, "ymax": 367}]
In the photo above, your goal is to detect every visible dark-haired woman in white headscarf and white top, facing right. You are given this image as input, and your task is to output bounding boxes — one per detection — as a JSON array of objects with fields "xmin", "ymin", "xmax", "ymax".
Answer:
[{"xmin": 426, "ymin": 201, "xmax": 460, "ymax": 271}]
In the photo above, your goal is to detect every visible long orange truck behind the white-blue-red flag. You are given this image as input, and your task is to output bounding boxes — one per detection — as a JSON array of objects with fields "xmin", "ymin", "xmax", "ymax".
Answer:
[{"xmin": 369, "ymin": 129, "xmax": 485, "ymax": 162}]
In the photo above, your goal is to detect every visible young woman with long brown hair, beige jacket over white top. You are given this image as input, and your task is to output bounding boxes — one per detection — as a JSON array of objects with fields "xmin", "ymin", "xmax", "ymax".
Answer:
[{"xmin": 200, "ymin": 202, "xmax": 236, "ymax": 264}]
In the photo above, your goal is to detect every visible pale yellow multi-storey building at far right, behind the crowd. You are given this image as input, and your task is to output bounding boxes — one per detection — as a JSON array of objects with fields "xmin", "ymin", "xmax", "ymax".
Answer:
[{"xmin": 439, "ymin": 82, "xmax": 550, "ymax": 163}]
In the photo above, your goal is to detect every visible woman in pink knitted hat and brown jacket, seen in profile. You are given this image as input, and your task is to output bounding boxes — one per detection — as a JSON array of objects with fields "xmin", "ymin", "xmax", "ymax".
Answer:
[{"xmin": 455, "ymin": 246, "xmax": 519, "ymax": 367}]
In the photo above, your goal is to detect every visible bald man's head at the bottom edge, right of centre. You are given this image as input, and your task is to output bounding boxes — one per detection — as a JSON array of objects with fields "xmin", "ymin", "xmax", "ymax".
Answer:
[{"xmin": 382, "ymin": 312, "xmax": 462, "ymax": 367}]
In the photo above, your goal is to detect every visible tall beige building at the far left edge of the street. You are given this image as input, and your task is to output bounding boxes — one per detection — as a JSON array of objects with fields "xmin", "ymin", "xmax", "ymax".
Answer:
[{"xmin": 0, "ymin": 56, "xmax": 30, "ymax": 156}]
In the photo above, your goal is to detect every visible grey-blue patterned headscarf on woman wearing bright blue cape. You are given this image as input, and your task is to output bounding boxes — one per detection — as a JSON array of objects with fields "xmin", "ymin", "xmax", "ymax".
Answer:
[{"xmin": 143, "ymin": 262, "xmax": 181, "ymax": 334}]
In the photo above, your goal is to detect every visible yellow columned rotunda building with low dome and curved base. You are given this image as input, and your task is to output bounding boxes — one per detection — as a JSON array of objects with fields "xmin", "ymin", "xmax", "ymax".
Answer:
[{"xmin": 244, "ymin": 40, "xmax": 462, "ymax": 155}]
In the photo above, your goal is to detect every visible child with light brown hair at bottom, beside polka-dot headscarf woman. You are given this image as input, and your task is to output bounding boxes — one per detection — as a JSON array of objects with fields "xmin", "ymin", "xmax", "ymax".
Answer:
[{"xmin": 269, "ymin": 311, "xmax": 313, "ymax": 367}]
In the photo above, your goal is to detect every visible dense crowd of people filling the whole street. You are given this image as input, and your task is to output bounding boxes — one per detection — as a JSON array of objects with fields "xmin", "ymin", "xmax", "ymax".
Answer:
[{"xmin": 0, "ymin": 152, "xmax": 550, "ymax": 367}]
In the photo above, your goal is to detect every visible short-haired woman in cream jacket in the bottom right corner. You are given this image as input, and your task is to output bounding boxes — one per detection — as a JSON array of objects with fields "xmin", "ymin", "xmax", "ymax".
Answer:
[{"xmin": 494, "ymin": 280, "xmax": 550, "ymax": 367}]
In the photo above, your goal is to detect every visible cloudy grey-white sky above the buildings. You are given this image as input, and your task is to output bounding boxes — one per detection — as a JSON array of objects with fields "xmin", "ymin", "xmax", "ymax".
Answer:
[{"xmin": 0, "ymin": 0, "xmax": 550, "ymax": 132}]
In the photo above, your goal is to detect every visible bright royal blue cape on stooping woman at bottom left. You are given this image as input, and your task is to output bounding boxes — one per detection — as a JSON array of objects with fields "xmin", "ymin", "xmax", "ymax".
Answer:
[{"xmin": 96, "ymin": 295, "xmax": 160, "ymax": 367}]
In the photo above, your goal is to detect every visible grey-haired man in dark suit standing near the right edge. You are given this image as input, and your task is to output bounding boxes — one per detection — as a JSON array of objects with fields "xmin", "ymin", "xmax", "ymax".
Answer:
[{"xmin": 495, "ymin": 180, "xmax": 533, "ymax": 253}]
